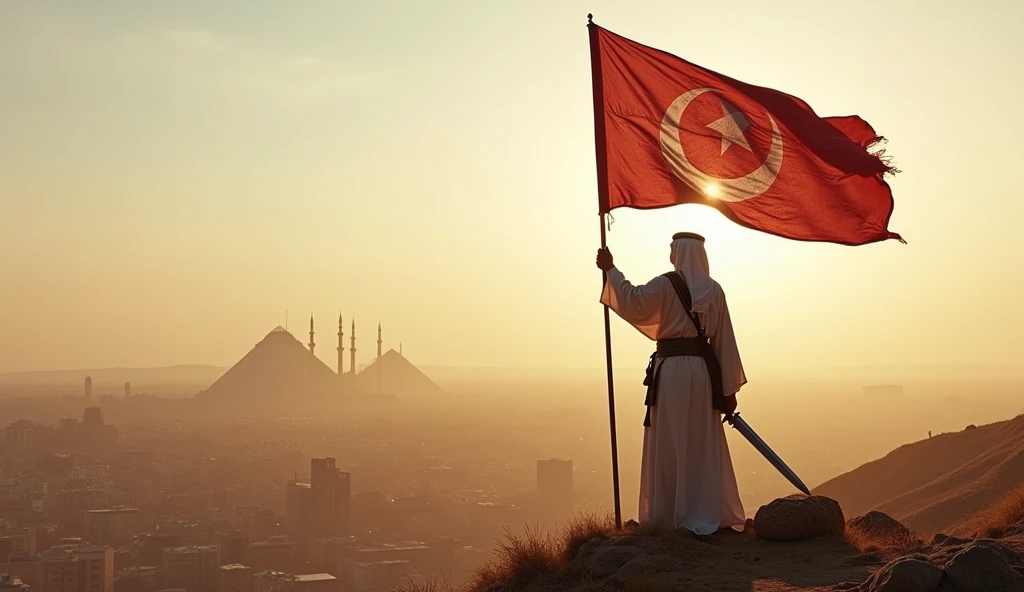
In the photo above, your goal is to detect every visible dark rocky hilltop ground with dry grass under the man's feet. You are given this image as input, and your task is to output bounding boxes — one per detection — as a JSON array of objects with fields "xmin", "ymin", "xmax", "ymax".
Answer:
[{"xmin": 486, "ymin": 497, "xmax": 1024, "ymax": 592}]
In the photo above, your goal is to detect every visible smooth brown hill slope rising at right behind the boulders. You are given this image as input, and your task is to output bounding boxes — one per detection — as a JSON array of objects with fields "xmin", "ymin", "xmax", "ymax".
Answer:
[{"xmin": 814, "ymin": 416, "xmax": 1024, "ymax": 533}]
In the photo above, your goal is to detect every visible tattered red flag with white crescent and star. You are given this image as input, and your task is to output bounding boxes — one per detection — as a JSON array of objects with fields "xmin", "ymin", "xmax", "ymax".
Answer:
[{"xmin": 590, "ymin": 24, "xmax": 901, "ymax": 245}]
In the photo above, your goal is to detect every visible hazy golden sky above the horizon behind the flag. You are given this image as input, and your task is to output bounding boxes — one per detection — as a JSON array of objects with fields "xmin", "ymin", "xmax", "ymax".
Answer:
[{"xmin": 0, "ymin": 0, "xmax": 1024, "ymax": 372}]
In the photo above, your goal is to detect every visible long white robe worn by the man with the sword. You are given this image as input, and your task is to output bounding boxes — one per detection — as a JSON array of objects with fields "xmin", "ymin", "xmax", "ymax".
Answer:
[{"xmin": 601, "ymin": 268, "xmax": 746, "ymax": 535}]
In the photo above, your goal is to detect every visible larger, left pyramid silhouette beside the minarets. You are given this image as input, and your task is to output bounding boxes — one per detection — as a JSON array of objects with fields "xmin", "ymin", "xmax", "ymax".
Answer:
[{"xmin": 197, "ymin": 327, "xmax": 343, "ymax": 409}]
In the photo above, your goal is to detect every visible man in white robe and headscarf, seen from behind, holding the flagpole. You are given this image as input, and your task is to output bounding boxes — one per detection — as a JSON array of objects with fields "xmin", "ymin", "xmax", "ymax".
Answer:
[{"xmin": 597, "ymin": 232, "xmax": 746, "ymax": 535}]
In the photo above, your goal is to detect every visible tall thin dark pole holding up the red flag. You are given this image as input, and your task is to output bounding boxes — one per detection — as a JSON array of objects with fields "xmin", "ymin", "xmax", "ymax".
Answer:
[{"xmin": 587, "ymin": 14, "xmax": 623, "ymax": 528}]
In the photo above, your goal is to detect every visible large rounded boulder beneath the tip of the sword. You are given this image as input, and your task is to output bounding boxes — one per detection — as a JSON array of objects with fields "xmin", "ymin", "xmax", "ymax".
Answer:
[{"xmin": 754, "ymin": 496, "xmax": 846, "ymax": 541}]
